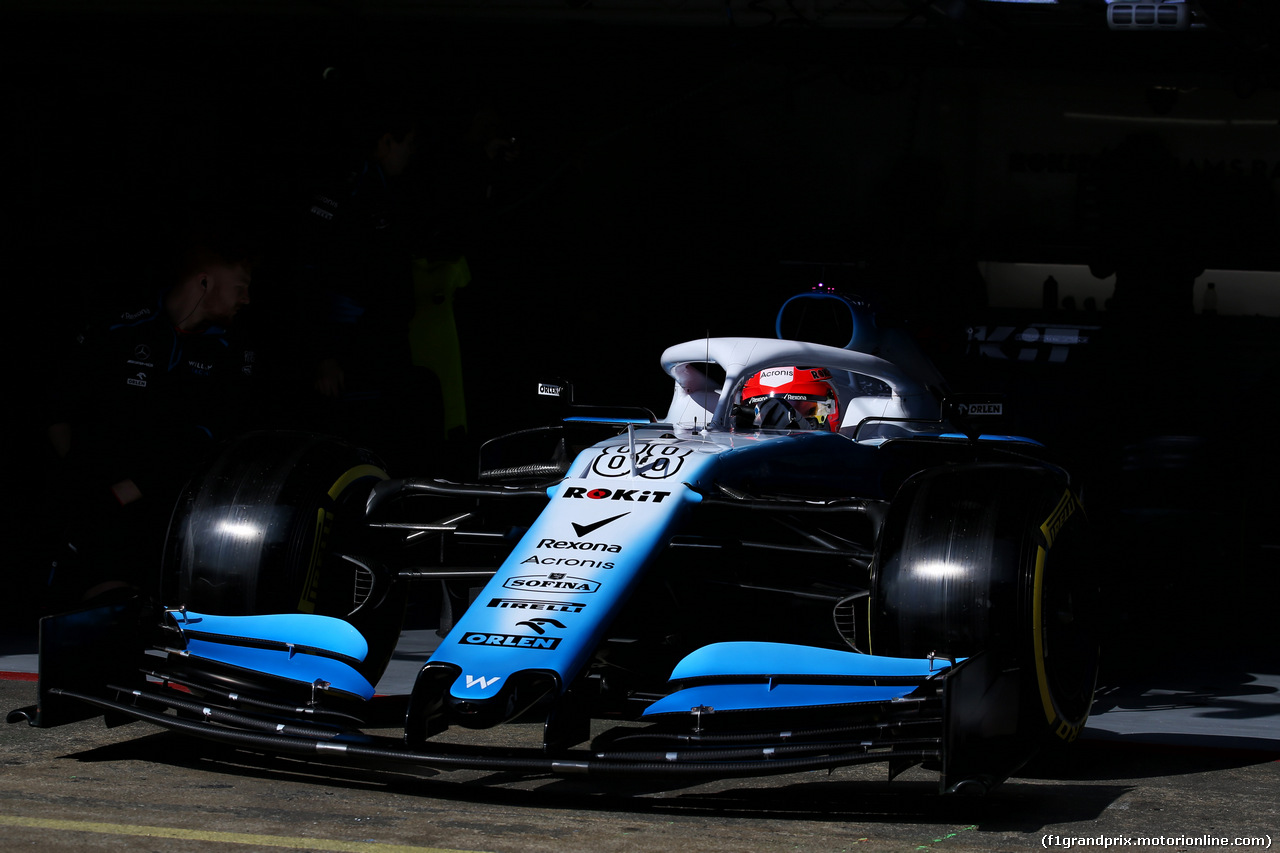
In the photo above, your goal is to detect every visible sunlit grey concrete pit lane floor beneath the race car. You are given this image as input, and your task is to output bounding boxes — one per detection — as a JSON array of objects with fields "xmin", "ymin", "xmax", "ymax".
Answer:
[{"xmin": 0, "ymin": 617, "xmax": 1280, "ymax": 853}]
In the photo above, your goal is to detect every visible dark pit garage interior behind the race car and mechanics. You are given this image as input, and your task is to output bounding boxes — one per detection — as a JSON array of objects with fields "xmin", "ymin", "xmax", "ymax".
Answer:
[{"xmin": 0, "ymin": 0, "xmax": 1280, "ymax": 749}]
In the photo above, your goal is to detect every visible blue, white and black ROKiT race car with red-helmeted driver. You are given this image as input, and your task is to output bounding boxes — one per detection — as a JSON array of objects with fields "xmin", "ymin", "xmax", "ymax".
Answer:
[{"xmin": 9, "ymin": 293, "xmax": 1098, "ymax": 793}]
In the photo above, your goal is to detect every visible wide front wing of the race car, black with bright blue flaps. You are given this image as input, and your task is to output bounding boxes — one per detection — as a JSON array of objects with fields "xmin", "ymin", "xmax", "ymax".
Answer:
[{"xmin": 9, "ymin": 599, "xmax": 1036, "ymax": 793}]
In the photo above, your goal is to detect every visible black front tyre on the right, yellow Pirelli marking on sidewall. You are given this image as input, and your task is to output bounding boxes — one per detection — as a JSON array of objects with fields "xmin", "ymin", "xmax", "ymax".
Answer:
[{"xmin": 868, "ymin": 464, "xmax": 1098, "ymax": 740}]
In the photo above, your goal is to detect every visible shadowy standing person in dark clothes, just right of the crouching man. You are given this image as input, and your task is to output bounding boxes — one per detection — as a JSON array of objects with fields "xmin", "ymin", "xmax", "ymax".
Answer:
[{"xmin": 301, "ymin": 93, "xmax": 443, "ymax": 462}]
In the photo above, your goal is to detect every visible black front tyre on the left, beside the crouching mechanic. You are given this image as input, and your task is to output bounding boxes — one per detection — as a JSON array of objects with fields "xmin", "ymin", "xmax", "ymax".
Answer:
[{"xmin": 161, "ymin": 432, "xmax": 404, "ymax": 683}]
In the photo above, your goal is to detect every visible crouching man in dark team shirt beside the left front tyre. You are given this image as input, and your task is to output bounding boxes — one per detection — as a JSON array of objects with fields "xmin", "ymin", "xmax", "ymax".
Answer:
[{"xmin": 44, "ymin": 227, "xmax": 256, "ymax": 610}]
